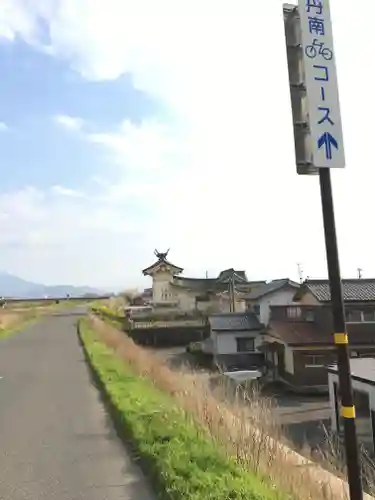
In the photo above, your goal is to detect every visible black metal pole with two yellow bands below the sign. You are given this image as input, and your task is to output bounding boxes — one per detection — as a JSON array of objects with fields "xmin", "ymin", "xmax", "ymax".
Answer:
[{"xmin": 319, "ymin": 168, "xmax": 363, "ymax": 500}]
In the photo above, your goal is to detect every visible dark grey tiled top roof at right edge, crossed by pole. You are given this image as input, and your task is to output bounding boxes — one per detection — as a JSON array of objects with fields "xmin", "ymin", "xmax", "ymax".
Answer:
[{"xmin": 305, "ymin": 279, "xmax": 375, "ymax": 302}]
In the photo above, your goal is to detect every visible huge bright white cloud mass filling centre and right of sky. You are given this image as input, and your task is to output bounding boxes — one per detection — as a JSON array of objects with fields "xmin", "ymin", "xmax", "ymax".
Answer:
[{"xmin": 0, "ymin": 0, "xmax": 375, "ymax": 286}]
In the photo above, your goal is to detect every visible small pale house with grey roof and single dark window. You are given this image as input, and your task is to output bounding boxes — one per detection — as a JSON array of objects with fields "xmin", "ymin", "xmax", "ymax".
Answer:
[{"xmin": 203, "ymin": 312, "xmax": 264, "ymax": 371}]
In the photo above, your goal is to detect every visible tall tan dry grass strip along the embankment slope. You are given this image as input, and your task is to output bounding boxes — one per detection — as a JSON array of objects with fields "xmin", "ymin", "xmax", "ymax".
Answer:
[{"xmin": 90, "ymin": 316, "xmax": 374, "ymax": 500}]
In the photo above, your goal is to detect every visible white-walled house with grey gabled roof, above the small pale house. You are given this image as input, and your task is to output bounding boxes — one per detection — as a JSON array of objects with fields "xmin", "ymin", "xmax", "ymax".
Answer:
[{"xmin": 241, "ymin": 278, "xmax": 300, "ymax": 326}]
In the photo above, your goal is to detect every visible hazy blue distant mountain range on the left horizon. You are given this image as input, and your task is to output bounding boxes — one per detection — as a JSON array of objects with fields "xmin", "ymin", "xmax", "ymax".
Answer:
[{"xmin": 0, "ymin": 273, "xmax": 108, "ymax": 299}]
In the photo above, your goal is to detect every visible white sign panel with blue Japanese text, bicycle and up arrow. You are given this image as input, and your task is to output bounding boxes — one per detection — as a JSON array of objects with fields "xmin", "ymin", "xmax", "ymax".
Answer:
[{"xmin": 298, "ymin": 0, "xmax": 345, "ymax": 168}]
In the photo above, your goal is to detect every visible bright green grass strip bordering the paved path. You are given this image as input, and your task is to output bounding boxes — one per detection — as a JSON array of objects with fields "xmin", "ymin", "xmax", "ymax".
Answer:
[{"xmin": 80, "ymin": 319, "xmax": 288, "ymax": 500}]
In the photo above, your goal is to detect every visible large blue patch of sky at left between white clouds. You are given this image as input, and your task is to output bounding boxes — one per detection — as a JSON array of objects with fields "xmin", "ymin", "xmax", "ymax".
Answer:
[{"xmin": 0, "ymin": 42, "xmax": 161, "ymax": 189}]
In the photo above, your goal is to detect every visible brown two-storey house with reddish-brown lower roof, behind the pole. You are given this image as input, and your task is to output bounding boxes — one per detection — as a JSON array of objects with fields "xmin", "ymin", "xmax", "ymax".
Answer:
[{"xmin": 263, "ymin": 301, "xmax": 375, "ymax": 392}]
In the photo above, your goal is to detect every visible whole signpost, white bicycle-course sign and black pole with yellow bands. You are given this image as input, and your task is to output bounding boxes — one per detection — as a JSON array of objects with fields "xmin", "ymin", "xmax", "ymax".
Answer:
[{"xmin": 283, "ymin": 0, "xmax": 363, "ymax": 500}]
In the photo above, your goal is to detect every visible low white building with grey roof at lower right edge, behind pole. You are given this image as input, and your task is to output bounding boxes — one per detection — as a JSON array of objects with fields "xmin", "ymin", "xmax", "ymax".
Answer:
[{"xmin": 328, "ymin": 358, "xmax": 375, "ymax": 452}]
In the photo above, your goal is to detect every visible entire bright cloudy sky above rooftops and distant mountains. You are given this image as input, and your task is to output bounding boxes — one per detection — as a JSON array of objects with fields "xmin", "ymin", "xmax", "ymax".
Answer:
[{"xmin": 0, "ymin": 0, "xmax": 375, "ymax": 288}]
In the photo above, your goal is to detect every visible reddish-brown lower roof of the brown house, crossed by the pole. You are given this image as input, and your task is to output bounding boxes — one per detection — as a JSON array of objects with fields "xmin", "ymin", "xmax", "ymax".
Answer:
[{"xmin": 268, "ymin": 321, "xmax": 375, "ymax": 347}]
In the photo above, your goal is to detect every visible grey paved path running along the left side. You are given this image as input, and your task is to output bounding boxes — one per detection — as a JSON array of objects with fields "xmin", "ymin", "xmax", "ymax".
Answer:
[{"xmin": 0, "ymin": 312, "xmax": 153, "ymax": 500}]
